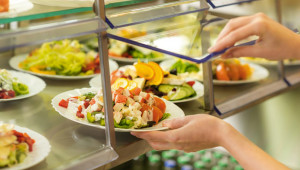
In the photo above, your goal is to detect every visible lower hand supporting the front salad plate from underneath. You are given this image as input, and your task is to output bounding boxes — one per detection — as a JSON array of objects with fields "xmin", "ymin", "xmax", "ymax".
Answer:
[{"xmin": 131, "ymin": 114, "xmax": 231, "ymax": 152}]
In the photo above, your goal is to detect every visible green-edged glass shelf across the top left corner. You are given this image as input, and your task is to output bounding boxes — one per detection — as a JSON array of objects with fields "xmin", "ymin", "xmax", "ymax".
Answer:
[{"xmin": 0, "ymin": 0, "xmax": 152, "ymax": 24}]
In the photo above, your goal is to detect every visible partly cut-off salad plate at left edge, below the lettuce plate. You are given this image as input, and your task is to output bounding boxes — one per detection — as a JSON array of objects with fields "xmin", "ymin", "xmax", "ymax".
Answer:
[{"xmin": 0, "ymin": 69, "xmax": 46, "ymax": 102}]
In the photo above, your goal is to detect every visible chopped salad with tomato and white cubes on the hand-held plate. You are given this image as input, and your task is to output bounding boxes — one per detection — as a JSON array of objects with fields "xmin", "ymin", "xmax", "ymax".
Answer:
[{"xmin": 59, "ymin": 87, "xmax": 170, "ymax": 129}]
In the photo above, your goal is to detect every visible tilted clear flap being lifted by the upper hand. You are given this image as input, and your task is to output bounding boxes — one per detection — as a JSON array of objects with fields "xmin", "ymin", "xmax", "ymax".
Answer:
[{"xmin": 108, "ymin": 12, "xmax": 225, "ymax": 63}]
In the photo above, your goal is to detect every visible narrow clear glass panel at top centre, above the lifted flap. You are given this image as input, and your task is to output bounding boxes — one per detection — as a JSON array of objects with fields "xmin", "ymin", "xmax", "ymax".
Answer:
[{"xmin": 106, "ymin": 0, "xmax": 209, "ymax": 28}]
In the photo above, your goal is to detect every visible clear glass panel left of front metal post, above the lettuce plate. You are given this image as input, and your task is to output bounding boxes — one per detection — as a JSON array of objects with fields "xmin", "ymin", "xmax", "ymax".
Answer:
[{"xmin": 0, "ymin": 15, "xmax": 107, "ymax": 52}]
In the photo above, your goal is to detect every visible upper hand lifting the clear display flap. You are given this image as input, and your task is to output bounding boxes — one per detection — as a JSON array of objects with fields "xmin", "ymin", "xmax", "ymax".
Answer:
[{"xmin": 209, "ymin": 13, "xmax": 300, "ymax": 60}]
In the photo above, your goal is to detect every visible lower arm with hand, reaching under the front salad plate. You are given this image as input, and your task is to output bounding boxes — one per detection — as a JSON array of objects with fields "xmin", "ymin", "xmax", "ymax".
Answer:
[{"xmin": 131, "ymin": 114, "xmax": 288, "ymax": 170}]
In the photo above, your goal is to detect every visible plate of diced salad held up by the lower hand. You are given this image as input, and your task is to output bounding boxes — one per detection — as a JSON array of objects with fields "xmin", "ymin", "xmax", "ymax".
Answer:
[{"xmin": 52, "ymin": 87, "xmax": 184, "ymax": 132}]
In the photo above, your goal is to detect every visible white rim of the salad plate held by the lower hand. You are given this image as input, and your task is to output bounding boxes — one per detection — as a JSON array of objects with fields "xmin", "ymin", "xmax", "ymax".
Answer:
[{"xmin": 51, "ymin": 87, "xmax": 185, "ymax": 132}]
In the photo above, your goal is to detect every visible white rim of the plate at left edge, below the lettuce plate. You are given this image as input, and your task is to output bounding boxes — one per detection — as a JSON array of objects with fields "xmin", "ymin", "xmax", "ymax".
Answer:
[{"xmin": 0, "ymin": 70, "xmax": 47, "ymax": 102}]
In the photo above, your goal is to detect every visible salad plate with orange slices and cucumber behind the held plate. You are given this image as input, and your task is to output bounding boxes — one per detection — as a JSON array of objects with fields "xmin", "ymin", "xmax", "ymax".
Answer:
[{"xmin": 90, "ymin": 62, "xmax": 204, "ymax": 103}]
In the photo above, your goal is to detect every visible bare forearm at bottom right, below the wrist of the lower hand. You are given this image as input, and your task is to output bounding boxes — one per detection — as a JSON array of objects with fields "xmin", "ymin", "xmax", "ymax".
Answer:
[{"xmin": 220, "ymin": 125, "xmax": 289, "ymax": 170}]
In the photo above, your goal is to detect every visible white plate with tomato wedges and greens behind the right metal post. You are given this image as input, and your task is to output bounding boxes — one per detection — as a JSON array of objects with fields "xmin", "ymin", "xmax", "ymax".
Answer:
[{"xmin": 160, "ymin": 59, "xmax": 269, "ymax": 85}]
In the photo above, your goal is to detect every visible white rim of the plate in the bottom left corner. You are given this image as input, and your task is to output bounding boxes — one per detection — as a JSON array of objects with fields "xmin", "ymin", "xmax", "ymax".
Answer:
[{"xmin": 1, "ymin": 124, "xmax": 51, "ymax": 170}]
